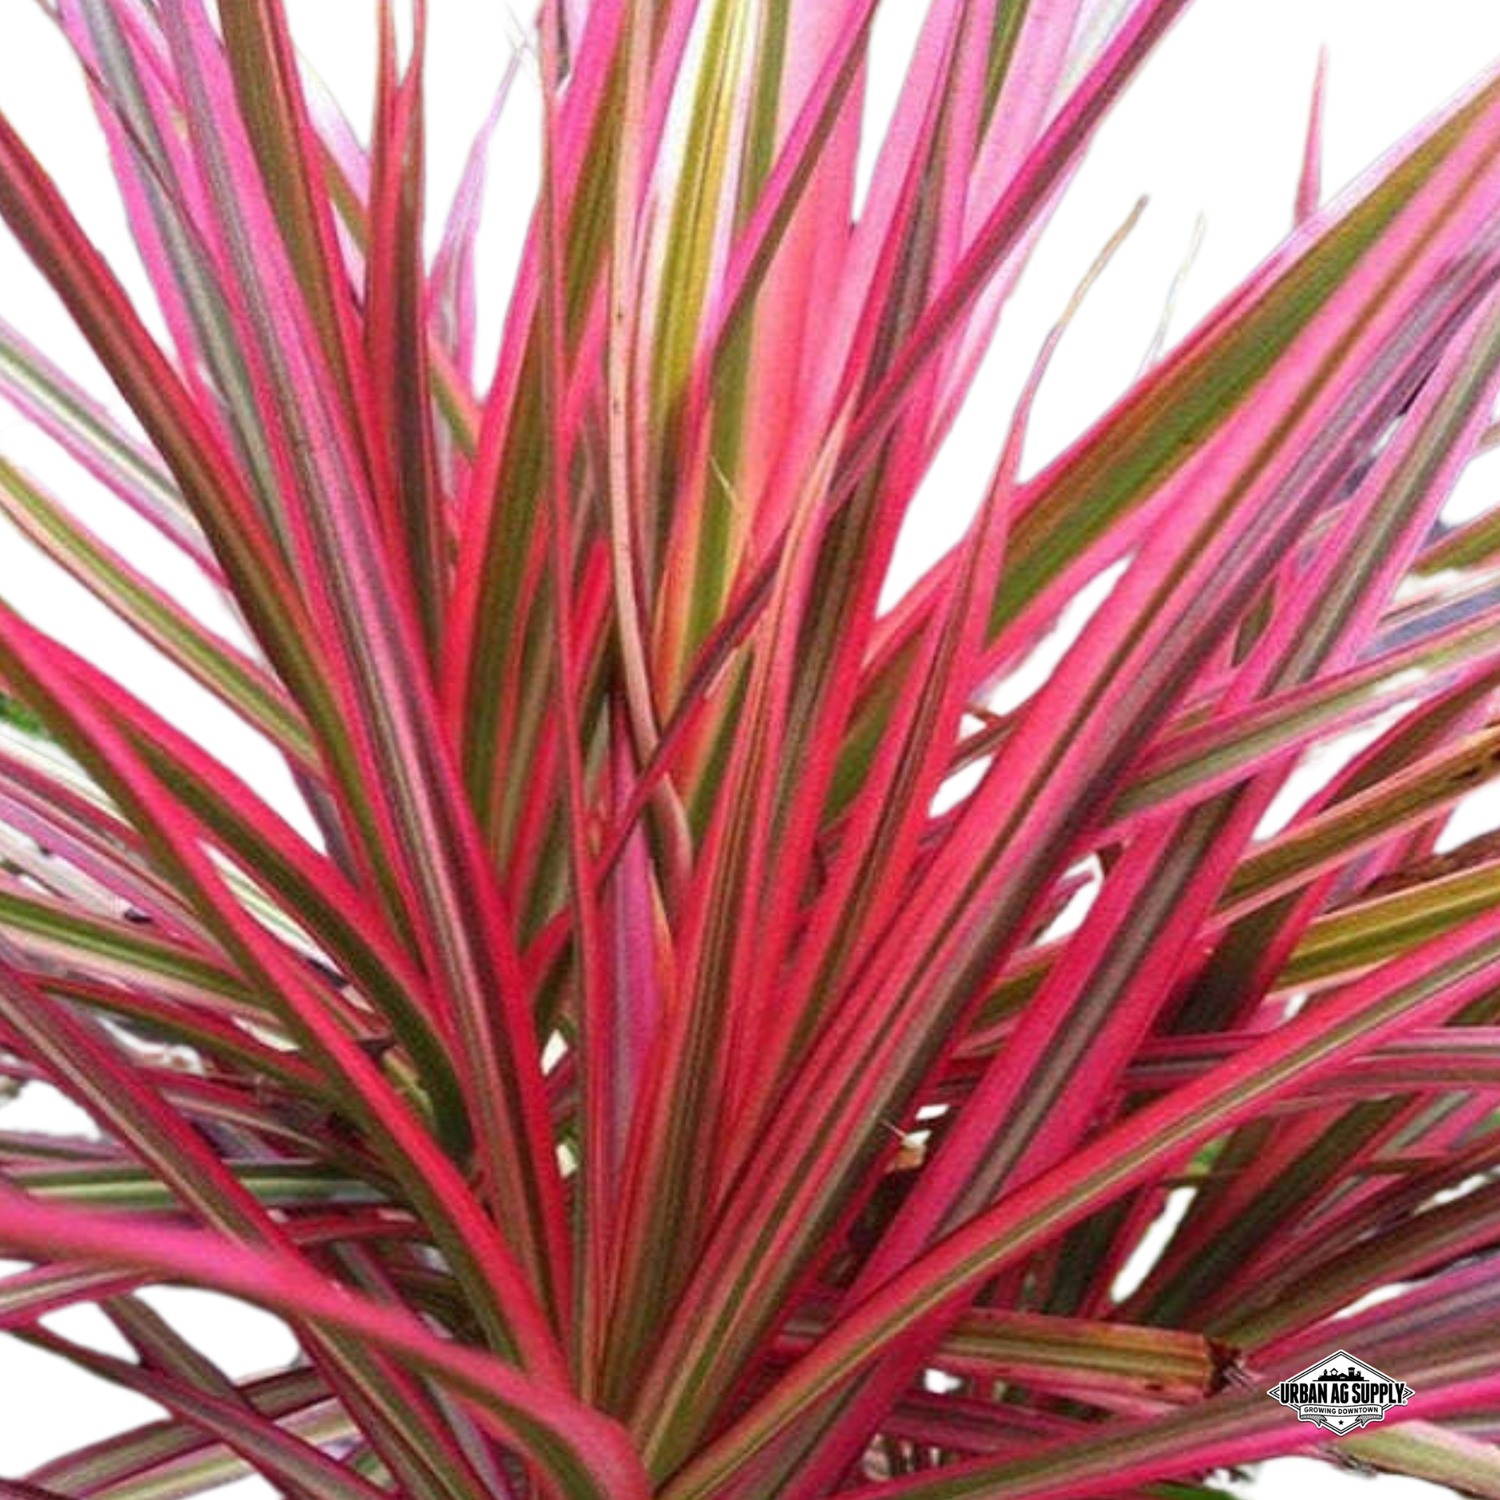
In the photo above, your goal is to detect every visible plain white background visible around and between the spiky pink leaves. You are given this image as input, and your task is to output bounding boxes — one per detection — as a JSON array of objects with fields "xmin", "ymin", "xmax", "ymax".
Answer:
[{"xmin": 0, "ymin": 0, "xmax": 1500, "ymax": 1497}]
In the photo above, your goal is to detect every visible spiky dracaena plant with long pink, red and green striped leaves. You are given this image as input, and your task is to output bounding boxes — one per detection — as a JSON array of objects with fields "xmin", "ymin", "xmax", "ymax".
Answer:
[{"xmin": 0, "ymin": 0, "xmax": 1500, "ymax": 1500}]
